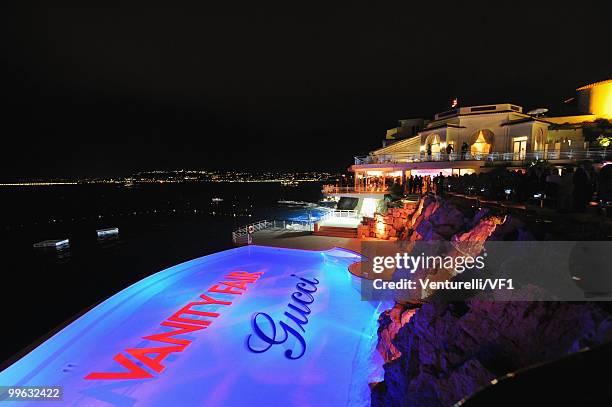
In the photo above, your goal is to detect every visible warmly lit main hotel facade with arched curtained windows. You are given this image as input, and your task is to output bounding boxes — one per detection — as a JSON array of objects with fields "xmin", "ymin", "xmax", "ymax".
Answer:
[{"xmin": 351, "ymin": 103, "xmax": 556, "ymax": 185}]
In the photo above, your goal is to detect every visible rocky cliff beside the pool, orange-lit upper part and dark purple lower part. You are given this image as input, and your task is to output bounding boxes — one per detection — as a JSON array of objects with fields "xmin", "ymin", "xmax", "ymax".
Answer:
[{"xmin": 372, "ymin": 197, "xmax": 612, "ymax": 406}]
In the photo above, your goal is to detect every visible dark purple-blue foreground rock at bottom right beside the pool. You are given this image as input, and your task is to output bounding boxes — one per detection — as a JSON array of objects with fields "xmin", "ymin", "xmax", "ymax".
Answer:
[{"xmin": 372, "ymin": 299, "xmax": 612, "ymax": 406}]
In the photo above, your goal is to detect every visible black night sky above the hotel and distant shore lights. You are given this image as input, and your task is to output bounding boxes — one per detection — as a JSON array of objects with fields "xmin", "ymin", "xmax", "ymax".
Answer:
[{"xmin": 0, "ymin": 1, "xmax": 612, "ymax": 180}]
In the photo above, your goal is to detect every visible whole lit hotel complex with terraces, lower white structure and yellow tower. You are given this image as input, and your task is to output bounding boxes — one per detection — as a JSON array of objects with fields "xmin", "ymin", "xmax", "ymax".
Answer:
[{"xmin": 316, "ymin": 79, "xmax": 612, "ymax": 233}]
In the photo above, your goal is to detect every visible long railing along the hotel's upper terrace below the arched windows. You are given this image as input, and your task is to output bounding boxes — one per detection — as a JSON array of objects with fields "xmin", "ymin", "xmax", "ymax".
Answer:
[{"xmin": 355, "ymin": 149, "xmax": 612, "ymax": 165}]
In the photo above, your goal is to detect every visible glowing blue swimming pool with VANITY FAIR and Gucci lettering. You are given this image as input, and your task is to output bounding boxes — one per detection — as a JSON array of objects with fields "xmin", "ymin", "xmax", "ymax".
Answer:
[{"xmin": 0, "ymin": 246, "xmax": 389, "ymax": 406}]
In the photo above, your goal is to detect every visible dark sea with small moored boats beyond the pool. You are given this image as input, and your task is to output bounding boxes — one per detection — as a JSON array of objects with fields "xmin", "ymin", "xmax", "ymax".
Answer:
[{"xmin": 0, "ymin": 183, "xmax": 330, "ymax": 363}]
